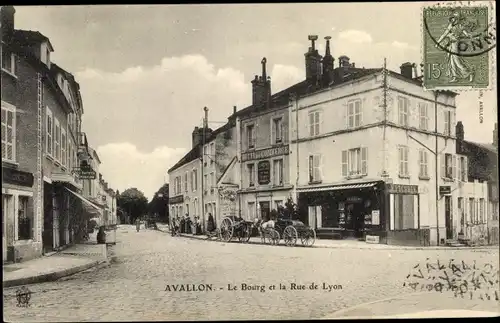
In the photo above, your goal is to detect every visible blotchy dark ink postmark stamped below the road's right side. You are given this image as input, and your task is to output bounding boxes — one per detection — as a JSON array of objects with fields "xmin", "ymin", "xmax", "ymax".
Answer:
[{"xmin": 403, "ymin": 258, "xmax": 500, "ymax": 301}]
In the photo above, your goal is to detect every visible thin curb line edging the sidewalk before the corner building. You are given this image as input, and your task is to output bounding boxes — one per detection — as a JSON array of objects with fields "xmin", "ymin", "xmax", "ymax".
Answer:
[{"xmin": 163, "ymin": 230, "xmax": 498, "ymax": 250}]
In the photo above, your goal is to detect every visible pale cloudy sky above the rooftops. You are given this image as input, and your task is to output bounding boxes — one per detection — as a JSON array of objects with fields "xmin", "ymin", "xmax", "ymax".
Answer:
[{"xmin": 11, "ymin": 2, "xmax": 497, "ymax": 199}]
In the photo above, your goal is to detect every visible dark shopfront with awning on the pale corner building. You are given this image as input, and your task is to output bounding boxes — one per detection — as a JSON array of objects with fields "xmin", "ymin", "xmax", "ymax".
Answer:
[{"xmin": 297, "ymin": 182, "xmax": 386, "ymax": 239}]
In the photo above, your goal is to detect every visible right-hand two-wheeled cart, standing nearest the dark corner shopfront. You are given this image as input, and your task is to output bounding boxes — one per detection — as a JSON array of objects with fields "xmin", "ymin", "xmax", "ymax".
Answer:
[{"xmin": 274, "ymin": 218, "xmax": 316, "ymax": 247}]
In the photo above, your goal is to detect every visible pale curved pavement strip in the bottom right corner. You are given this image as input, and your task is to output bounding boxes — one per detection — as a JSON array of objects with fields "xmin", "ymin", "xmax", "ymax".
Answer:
[{"xmin": 325, "ymin": 291, "xmax": 500, "ymax": 319}]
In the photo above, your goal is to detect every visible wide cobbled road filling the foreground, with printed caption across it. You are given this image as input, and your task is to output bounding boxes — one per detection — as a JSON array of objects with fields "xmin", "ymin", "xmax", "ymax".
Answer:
[{"xmin": 4, "ymin": 226, "xmax": 498, "ymax": 322}]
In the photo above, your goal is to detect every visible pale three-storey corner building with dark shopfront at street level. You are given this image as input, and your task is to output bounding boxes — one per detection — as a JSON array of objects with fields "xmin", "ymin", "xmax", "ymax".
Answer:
[{"xmin": 290, "ymin": 36, "xmax": 487, "ymax": 245}]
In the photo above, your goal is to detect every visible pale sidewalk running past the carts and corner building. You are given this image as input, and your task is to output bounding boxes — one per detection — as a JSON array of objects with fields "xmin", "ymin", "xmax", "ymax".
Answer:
[{"xmin": 158, "ymin": 224, "xmax": 498, "ymax": 250}]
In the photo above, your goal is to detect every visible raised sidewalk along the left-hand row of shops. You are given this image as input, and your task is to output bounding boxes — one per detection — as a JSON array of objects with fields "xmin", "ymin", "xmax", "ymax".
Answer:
[{"xmin": 3, "ymin": 244, "xmax": 107, "ymax": 288}]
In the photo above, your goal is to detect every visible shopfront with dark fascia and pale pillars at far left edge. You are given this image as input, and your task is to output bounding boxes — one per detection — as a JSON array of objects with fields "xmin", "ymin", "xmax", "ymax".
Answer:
[{"xmin": 2, "ymin": 167, "xmax": 42, "ymax": 262}]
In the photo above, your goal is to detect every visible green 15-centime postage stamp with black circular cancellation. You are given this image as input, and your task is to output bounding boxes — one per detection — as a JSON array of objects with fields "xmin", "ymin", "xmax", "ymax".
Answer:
[{"xmin": 422, "ymin": 2, "xmax": 496, "ymax": 90}]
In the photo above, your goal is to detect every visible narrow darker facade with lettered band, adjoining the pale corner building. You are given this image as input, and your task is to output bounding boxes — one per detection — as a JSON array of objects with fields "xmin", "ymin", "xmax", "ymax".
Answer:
[{"xmin": 236, "ymin": 58, "xmax": 293, "ymax": 220}]
